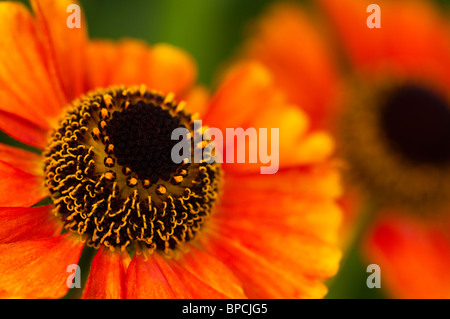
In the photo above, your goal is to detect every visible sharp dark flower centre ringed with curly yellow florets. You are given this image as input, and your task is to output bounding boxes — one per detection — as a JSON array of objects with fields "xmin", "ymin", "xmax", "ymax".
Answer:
[{"xmin": 44, "ymin": 87, "xmax": 221, "ymax": 252}]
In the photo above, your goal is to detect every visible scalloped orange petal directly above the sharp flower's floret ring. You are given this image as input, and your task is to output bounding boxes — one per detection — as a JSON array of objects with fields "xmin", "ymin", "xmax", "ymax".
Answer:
[{"xmin": 87, "ymin": 39, "xmax": 197, "ymax": 95}]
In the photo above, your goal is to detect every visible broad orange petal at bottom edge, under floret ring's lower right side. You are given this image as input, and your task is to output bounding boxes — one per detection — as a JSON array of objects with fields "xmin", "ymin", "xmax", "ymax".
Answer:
[{"xmin": 126, "ymin": 246, "xmax": 244, "ymax": 299}]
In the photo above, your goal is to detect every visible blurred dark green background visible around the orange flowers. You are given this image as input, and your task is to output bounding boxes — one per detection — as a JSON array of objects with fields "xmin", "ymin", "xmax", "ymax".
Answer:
[{"xmin": 5, "ymin": 0, "xmax": 450, "ymax": 298}]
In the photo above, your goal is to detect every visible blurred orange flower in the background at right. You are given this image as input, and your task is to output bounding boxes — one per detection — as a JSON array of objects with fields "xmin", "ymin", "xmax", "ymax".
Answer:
[{"xmin": 243, "ymin": 0, "xmax": 450, "ymax": 298}]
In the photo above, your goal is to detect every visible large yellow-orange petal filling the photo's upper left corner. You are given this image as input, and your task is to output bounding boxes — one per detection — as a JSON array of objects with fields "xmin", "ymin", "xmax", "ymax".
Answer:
[{"xmin": 0, "ymin": 2, "xmax": 62, "ymax": 131}]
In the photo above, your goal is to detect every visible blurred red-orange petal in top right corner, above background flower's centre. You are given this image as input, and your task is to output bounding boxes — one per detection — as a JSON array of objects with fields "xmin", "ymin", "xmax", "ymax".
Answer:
[{"xmin": 320, "ymin": 0, "xmax": 450, "ymax": 85}]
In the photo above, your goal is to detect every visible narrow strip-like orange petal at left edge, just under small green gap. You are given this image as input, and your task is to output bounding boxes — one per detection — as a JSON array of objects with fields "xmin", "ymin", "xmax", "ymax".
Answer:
[{"xmin": 0, "ymin": 144, "xmax": 42, "ymax": 175}]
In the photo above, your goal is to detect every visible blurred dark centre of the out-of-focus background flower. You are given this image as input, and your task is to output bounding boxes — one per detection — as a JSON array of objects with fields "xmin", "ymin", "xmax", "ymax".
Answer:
[{"xmin": 380, "ymin": 85, "xmax": 450, "ymax": 165}]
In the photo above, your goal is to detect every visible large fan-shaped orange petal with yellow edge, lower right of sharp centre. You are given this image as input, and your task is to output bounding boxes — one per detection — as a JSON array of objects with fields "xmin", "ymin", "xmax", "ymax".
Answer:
[{"xmin": 200, "ymin": 169, "xmax": 341, "ymax": 298}]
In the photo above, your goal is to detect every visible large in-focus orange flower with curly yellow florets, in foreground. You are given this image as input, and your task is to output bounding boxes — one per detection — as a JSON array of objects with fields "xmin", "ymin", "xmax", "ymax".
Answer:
[{"xmin": 0, "ymin": 0, "xmax": 341, "ymax": 298}]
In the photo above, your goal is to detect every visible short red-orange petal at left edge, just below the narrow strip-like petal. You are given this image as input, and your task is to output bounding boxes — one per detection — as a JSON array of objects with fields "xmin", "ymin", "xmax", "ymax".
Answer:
[{"xmin": 0, "ymin": 161, "xmax": 47, "ymax": 207}]
